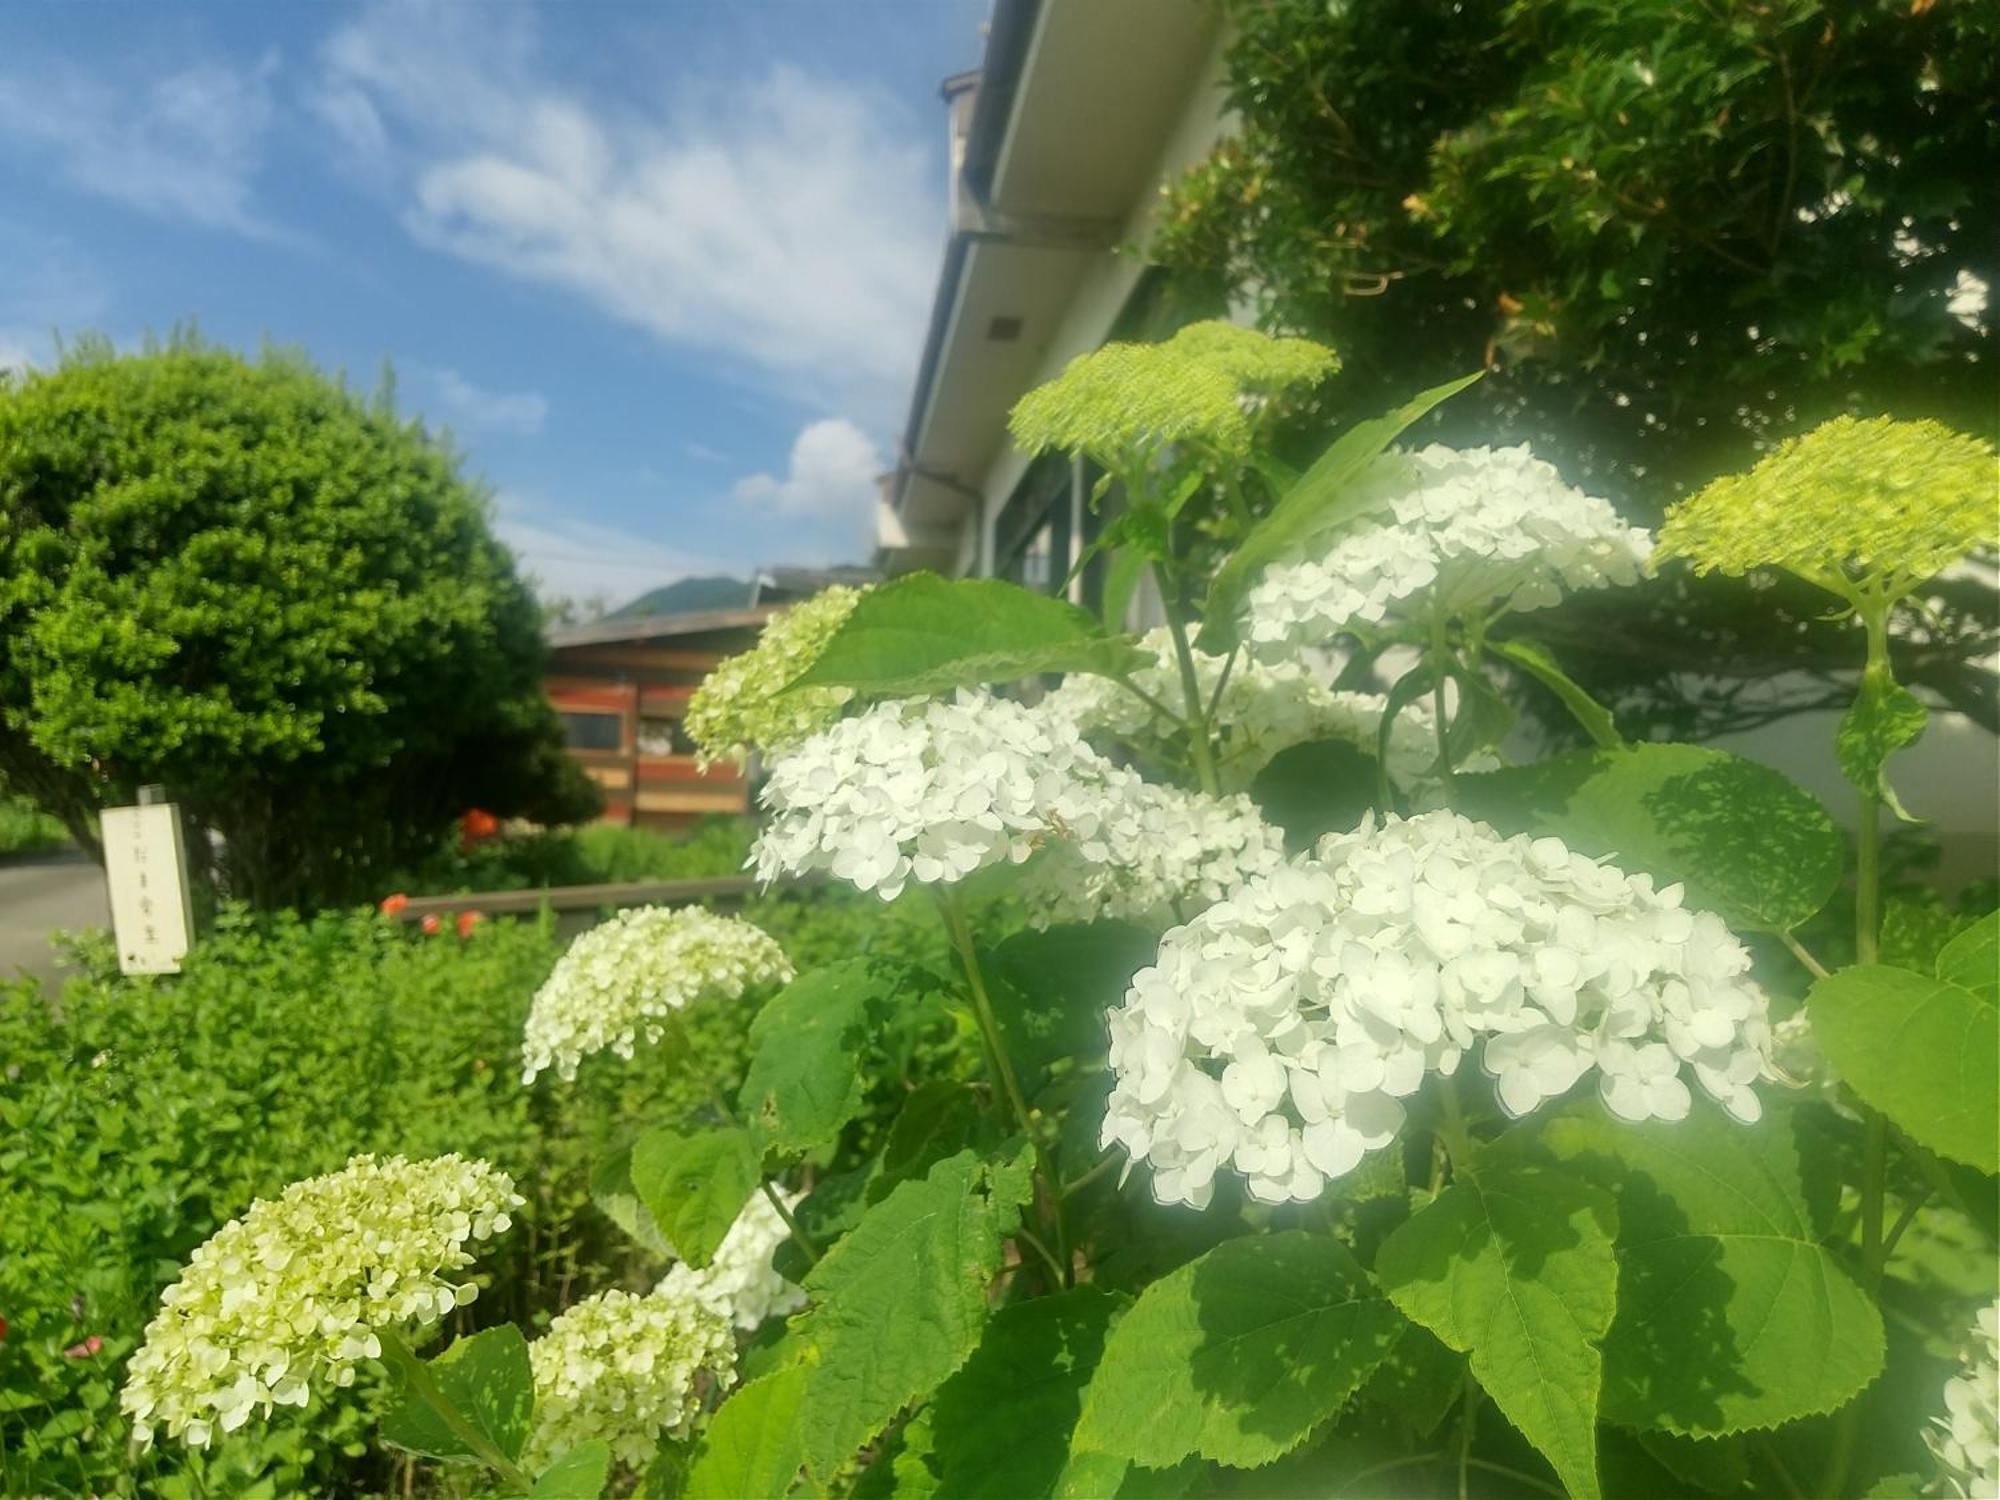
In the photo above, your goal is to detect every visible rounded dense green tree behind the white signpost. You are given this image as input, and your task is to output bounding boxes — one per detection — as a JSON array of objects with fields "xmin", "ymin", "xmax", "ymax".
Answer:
[{"xmin": 0, "ymin": 338, "xmax": 594, "ymax": 908}]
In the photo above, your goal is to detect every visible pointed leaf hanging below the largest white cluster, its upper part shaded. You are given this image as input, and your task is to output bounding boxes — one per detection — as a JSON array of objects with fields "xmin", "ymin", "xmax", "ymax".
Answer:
[{"xmin": 1376, "ymin": 1160, "xmax": 1618, "ymax": 1500}]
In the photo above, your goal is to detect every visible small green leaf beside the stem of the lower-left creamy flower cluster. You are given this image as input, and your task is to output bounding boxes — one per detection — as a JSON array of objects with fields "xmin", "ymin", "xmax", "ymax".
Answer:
[{"xmin": 382, "ymin": 1324, "xmax": 534, "ymax": 1462}]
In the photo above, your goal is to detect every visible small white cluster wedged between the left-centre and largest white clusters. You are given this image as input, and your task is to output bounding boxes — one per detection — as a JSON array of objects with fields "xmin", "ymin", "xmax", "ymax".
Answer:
[{"xmin": 1016, "ymin": 770, "xmax": 1284, "ymax": 928}]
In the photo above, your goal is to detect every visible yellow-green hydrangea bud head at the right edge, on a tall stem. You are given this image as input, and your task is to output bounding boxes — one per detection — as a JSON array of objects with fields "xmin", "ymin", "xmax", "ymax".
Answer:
[{"xmin": 1654, "ymin": 416, "xmax": 2000, "ymax": 600}]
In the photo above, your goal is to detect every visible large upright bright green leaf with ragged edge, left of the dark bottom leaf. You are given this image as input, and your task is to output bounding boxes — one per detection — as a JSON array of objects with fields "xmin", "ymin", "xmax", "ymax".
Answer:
[{"xmin": 798, "ymin": 1146, "xmax": 1034, "ymax": 1480}]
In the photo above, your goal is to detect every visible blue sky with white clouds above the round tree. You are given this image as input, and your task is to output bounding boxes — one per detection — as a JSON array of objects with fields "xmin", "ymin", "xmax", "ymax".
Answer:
[{"xmin": 0, "ymin": 0, "xmax": 988, "ymax": 600}]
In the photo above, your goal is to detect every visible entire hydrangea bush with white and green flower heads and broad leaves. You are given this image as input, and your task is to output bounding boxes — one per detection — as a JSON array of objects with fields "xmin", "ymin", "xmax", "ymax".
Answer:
[{"xmin": 97, "ymin": 324, "xmax": 2000, "ymax": 1500}]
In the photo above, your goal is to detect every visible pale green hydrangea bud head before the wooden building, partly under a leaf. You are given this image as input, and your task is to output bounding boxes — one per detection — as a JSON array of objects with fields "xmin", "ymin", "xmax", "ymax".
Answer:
[{"xmin": 684, "ymin": 586, "xmax": 866, "ymax": 768}]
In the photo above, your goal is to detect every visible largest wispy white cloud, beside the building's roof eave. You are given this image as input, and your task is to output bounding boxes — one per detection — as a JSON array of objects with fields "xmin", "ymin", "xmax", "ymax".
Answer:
[{"xmin": 316, "ymin": 4, "xmax": 942, "ymax": 420}]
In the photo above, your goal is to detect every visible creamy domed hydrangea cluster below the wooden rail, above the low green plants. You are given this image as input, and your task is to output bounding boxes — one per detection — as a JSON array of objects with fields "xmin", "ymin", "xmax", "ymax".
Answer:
[{"xmin": 522, "ymin": 906, "xmax": 792, "ymax": 1084}]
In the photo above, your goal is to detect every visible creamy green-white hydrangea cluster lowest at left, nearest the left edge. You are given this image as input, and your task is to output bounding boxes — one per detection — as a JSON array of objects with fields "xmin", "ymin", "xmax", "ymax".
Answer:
[{"xmin": 120, "ymin": 1156, "xmax": 522, "ymax": 1448}]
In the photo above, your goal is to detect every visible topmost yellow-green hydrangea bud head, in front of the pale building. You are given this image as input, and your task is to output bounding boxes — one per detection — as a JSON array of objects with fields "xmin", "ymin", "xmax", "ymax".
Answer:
[{"xmin": 1008, "ymin": 322, "xmax": 1340, "ymax": 468}]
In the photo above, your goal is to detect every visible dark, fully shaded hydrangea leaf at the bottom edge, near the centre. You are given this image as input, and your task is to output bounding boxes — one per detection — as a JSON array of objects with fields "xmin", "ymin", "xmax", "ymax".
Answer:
[{"xmin": 930, "ymin": 1286, "xmax": 1118, "ymax": 1500}]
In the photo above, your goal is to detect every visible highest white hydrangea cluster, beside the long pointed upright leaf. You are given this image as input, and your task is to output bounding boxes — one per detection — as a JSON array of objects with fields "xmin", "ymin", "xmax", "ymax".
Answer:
[{"xmin": 1246, "ymin": 444, "xmax": 1652, "ymax": 652}]
